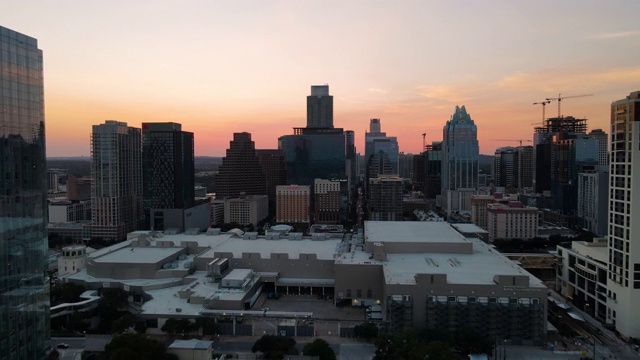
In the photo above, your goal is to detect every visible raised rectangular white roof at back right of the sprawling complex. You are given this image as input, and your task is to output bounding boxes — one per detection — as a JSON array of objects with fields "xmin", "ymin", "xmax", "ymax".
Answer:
[{"xmin": 364, "ymin": 221, "xmax": 467, "ymax": 244}]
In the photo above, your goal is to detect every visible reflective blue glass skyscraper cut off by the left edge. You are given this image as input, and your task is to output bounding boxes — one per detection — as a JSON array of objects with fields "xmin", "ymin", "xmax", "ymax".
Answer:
[{"xmin": 0, "ymin": 26, "xmax": 49, "ymax": 359}]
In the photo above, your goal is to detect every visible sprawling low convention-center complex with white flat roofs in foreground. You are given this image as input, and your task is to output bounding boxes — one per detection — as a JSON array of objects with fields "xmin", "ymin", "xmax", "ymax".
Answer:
[{"xmin": 62, "ymin": 221, "xmax": 547, "ymax": 344}]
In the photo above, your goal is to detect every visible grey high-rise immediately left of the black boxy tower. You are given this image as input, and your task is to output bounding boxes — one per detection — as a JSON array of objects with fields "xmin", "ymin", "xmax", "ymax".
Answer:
[{"xmin": 91, "ymin": 120, "xmax": 144, "ymax": 241}]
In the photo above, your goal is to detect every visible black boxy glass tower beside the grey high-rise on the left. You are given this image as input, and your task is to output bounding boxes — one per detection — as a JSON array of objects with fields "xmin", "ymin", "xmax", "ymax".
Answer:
[{"xmin": 142, "ymin": 123, "xmax": 195, "ymax": 224}]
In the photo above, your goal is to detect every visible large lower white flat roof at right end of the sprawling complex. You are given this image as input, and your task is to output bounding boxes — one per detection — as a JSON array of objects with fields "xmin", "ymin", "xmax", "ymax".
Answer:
[{"xmin": 382, "ymin": 239, "xmax": 544, "ymax": 287}]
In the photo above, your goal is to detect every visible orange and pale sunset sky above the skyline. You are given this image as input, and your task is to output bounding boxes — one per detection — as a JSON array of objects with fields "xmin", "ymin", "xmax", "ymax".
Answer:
[{"xmin": 0, "ymin": 0, "xmax": 640, "ymax": 156}]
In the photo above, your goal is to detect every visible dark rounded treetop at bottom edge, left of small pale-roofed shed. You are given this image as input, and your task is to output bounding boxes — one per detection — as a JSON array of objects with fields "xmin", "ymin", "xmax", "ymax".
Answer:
[{"xmin": 98, "ymin": 333, "xmax": 174, "ymax": 360}]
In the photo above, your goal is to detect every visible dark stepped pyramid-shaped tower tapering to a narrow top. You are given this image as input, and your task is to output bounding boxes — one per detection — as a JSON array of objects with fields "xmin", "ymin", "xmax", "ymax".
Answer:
[{"xmin": 216, "ymin": 132, "xmax": 267, "ymax": 198}]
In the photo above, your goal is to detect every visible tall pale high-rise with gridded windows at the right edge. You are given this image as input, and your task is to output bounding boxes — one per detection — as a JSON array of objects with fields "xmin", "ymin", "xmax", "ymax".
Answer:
[{"xmin": 607, "ymin": 91, "xmax": 640, "ymax": 338}]
